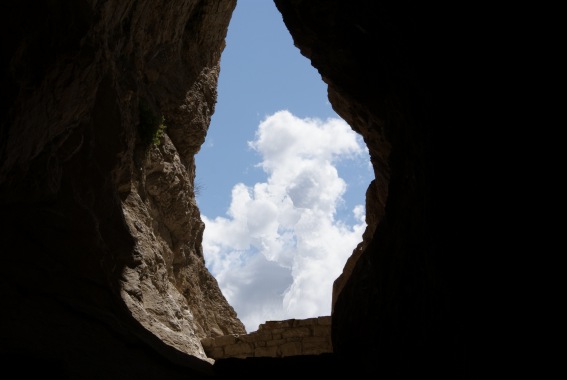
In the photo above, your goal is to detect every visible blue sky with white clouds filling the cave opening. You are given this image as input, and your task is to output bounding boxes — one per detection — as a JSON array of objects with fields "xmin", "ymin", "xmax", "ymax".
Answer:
[{"xmin": 195, "ymin": 0, "xmax": 374, "ymax": 333}]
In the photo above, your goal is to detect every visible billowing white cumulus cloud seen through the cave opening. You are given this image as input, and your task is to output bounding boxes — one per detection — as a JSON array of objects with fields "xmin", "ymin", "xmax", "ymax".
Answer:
[{"xmin": 202, "ymin": 111, "xmax": 368, "ymax": 332}]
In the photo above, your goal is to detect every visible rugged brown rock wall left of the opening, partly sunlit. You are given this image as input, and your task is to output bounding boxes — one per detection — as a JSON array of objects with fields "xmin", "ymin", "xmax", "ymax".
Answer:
[{"xmin": 0, "ymin": 0, "xmax": 245, "ymax": 378}]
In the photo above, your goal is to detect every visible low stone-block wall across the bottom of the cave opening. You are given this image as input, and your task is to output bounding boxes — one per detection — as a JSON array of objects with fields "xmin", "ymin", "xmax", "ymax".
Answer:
[{"xmin": 201, "ymin": 316, "xmax": 333, "ymax": 359}]
